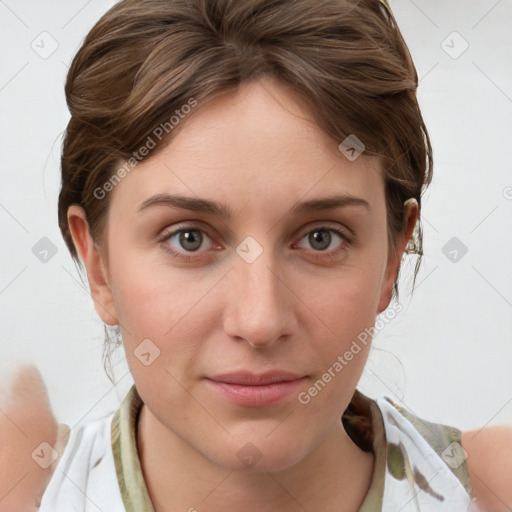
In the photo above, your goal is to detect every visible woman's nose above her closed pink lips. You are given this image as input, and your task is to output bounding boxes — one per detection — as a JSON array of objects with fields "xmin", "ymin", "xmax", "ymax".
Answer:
[{"xmin": 224, "ymin": 242, "xmax": 295, "ymax": 348}]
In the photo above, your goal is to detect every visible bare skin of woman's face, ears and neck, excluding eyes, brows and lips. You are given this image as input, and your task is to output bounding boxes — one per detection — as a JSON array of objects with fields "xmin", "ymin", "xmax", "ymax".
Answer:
[{"xmin": 68, "ymin": 77, "xmax": 417, "ymax": 512}]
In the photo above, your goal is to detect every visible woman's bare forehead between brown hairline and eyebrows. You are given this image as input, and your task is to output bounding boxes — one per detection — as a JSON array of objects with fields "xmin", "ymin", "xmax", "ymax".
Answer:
[{"xmin": 112, "ymin": 80, "xmax": 383, "ymax": 217}]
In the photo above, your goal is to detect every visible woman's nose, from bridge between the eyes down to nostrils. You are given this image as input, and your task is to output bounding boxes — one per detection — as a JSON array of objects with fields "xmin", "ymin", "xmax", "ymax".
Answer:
[{"xmin": 225, "ymin": 237, "xmax": 290, "ymax": 346}]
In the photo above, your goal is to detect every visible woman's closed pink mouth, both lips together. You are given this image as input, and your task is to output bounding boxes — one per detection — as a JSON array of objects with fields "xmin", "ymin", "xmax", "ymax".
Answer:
[{"xmin": 205, "ymin": 370, "xmax": 308, "ymax": 407}]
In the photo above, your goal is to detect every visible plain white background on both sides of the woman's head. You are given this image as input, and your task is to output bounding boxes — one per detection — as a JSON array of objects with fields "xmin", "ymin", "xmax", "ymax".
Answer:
[{"xmin": 0, "ymin": 0, "xmax": 512, "ymax": 429}]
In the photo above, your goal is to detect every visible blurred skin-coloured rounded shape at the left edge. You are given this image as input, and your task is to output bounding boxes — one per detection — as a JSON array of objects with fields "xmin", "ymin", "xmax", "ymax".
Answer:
[{"xmin": 0, "ymin": 365, "xmax": 62, "ymax": 512}]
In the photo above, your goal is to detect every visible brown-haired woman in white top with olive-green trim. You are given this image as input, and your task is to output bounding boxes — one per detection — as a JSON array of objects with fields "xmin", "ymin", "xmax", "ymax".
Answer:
[{"xmin": 5, "ymin": 0, "xmax": 512, "ymax": 512}]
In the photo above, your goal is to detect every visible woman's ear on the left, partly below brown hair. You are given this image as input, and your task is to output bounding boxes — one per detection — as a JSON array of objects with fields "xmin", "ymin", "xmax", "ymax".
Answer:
[{"xmin": 67, "ymin": 204, "xmax": 119, "ymax": 325}]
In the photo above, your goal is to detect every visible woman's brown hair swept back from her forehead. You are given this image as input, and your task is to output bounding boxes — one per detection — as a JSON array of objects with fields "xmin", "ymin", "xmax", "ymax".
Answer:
[{"xmin": 58, "ymin": 0, "xmax": 432, "ymax": 380}]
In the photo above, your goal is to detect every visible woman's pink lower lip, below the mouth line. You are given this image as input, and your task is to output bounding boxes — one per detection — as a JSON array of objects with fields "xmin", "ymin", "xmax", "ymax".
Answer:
[{"xmin": 205, "ymin": 377, "xmax": 306, "ymax": 407}]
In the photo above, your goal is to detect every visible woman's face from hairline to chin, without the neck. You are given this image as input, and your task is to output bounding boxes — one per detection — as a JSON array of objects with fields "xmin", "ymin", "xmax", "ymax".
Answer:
[{"xmin": 80, "ymin": 80, "xmax": 397, "ymax": 470}]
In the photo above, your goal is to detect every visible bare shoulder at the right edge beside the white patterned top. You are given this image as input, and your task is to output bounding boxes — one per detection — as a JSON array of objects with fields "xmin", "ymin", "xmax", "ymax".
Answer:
[{"xmin": 462, "ymin": 426, "xmax": 512, "ymax": 512}]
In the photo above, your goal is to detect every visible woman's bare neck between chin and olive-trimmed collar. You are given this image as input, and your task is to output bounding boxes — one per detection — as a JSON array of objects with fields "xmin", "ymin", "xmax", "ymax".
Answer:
[{"xmin": 137, "ymin": 406, "xmax": 373, "ymax": 512}]
